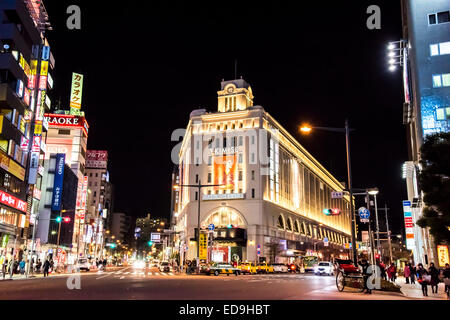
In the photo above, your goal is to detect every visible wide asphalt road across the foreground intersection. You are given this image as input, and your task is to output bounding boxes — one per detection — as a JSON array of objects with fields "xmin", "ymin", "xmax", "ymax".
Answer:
[{"xmin": 0, "ymin": 267, "xmax": 407, "ymax": 300}]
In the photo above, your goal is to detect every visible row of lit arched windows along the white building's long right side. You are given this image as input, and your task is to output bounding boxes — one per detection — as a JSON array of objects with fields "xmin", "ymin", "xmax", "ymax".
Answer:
[{"xmin": 277, "ymin": 215, "xmax": 347, "ymax": 244}]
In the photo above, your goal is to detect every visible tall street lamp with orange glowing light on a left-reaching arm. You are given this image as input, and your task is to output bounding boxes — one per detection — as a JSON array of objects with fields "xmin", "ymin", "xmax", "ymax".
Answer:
[{"xmin": 300, "ymin": 119, "xmax": 358, "ymax": 266}]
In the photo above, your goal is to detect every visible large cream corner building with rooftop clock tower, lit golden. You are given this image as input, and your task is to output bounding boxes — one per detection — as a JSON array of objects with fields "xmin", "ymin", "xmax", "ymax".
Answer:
[{"xmin": 172, "ymin": 79, "xmax": 351, "ymax": 262}]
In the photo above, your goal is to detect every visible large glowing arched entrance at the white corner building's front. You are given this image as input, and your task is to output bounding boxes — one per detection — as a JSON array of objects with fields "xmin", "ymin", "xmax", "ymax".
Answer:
[{"xmin": 202, "ymin": 206, "xmax": 247, "ymax": 263}]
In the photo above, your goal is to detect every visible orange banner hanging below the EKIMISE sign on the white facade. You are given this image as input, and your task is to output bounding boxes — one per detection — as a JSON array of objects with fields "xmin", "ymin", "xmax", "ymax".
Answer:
[{"xmin": 213, "ymin": 154, "xmax": 237, "ymax": 190}]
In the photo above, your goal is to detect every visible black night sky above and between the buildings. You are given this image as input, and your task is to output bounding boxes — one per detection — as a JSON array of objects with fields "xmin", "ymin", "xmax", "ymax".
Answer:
[{"xmin": 44, "ymin": 0, "xmax": 407, "ymax": 233}]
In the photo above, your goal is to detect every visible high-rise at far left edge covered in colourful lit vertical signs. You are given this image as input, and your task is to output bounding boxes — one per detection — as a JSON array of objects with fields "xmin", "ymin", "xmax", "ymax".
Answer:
[{"xmin": 0, "ymin": 0, "xmax": 55, "ymax": 260}]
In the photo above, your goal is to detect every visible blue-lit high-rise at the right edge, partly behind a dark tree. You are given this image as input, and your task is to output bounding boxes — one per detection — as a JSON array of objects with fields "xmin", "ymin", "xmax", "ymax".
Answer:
[{"xmin": 400, "ymin": 0, "xmax": 450, "ymax": 264}]
